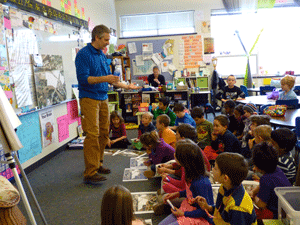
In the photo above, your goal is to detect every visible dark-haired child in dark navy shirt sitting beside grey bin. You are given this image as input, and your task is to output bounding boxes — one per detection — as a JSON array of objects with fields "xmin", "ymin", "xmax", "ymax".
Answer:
[{"xmin": 249, "ymin": 142, "xmax": 291, "ymax": 219}]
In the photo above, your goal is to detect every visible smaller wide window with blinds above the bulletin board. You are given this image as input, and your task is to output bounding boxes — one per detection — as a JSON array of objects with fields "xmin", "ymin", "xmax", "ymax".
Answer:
[{"xmin": 120, "ymin": 11, "xmax": 195, "ymax": 38}]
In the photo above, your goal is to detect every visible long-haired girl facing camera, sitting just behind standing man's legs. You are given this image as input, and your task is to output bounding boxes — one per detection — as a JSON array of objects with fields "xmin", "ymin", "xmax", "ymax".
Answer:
[{"xmin": 107, "ymin": 111, "xmax": 130, "ymax": 148}]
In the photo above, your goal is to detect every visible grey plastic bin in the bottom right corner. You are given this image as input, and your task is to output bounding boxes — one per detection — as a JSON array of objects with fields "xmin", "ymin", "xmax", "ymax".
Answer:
[{"xmin": 274, "ymin": 187, "xmax": 300, "ymax": 225}]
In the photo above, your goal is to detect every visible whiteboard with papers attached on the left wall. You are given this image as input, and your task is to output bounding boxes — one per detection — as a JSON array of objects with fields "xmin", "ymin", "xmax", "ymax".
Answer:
[{"xmin": 3, "ymin": 5, "xmax": 79, "ymax": 114}]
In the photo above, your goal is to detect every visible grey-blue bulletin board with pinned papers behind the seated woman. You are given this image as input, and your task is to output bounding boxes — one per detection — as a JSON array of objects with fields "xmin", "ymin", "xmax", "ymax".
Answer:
[{"xmin": 127, "ymin": 39, "xmax": 173, "ymax": 81}]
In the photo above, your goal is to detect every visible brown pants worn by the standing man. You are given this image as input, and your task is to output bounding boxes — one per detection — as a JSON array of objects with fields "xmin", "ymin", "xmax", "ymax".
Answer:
[{"xmin": 80, "ymin": 98, "xmax": 110, "ymax": 177}]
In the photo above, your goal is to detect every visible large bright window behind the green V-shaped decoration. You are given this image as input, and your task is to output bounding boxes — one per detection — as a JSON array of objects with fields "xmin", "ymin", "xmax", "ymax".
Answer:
[{"xmin": 211, "ymin": 7, "xmax": 300, "ymax": 75}]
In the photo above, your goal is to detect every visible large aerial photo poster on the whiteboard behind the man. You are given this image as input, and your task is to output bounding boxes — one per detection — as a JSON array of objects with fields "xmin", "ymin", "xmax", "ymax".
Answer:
[{"xmin": 34, "ymin": 55, "xmax": 67, "ymax": 108}]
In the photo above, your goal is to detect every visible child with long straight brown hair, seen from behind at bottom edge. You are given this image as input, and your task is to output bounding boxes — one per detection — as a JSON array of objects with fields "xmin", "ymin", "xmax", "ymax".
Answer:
[{"xmin": 101, "ymin": 185, "xmax": 144, "ymax": 225}]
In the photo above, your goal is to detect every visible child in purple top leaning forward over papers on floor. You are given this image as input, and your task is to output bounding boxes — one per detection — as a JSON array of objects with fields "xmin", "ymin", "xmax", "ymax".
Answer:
[{"xmin": 140, "ymin": 130, "xmax": 175, "ymax": 178}]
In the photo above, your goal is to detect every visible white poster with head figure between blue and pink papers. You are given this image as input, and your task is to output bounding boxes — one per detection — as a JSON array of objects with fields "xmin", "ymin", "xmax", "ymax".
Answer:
[{"xmin": 39, "ymin": 109, "xmax": 57, "ymax": 148}]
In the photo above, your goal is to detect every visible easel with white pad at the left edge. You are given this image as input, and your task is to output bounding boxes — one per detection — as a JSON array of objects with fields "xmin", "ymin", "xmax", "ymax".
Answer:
[{"xmin": 0, "ymin": 92, "xmax": 47, "ymax": 225}]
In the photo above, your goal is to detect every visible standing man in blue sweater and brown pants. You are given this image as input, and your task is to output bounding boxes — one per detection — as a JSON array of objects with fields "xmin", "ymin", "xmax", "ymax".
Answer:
[{"xmin": 75, "ymin": 25, "xmax": 138, "ymax": 184}]
